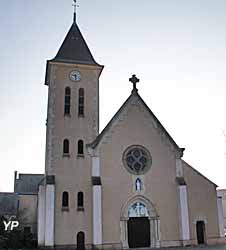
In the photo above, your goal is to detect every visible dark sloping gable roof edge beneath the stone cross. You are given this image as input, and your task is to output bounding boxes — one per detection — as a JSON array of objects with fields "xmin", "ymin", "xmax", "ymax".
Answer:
[{"xmin": 87, "ymin": 90, "xmax": 184, "ymax": 156}]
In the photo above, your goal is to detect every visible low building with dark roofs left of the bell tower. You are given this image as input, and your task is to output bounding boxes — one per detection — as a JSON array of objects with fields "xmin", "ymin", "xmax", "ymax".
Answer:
[{"xmin": 0, "ymin": 171, "xmax": 44, "ymax": 239}]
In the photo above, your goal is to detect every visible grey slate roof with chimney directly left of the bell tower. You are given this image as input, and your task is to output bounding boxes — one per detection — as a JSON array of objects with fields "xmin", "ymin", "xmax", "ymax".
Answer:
[{"xmin": 14, "ymin": 174, "xmax": 44, "ymax": 194}]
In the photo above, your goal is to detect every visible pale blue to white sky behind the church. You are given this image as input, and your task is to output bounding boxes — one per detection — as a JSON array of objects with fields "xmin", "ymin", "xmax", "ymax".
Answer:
[{"xmin": 0, "ymin": 0, "xmax": 226, "ymax": 191}]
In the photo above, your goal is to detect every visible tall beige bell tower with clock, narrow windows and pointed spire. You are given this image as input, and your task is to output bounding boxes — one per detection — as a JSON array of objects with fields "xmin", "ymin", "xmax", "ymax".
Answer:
[{"xmin": 38, "ymin": 7, "xmax": 103, "ymax": 246}]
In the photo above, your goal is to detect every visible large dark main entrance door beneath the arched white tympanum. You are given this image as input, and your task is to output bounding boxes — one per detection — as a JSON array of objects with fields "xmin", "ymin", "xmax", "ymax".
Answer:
[{"xmin": 127, "ymin": 217, "xmax": 150, "ymax": 248}]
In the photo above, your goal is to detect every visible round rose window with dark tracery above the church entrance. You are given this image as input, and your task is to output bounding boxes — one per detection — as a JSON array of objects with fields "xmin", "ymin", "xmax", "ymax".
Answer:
[{"xmin": 123, "ymin": 145, "xmax": 152, "ymax": 175}]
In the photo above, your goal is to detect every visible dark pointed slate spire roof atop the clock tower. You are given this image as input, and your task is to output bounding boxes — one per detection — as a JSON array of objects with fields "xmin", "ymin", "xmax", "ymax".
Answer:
[{"xmin": 51, "ymin": 22, "xmax": 100, "ymax": 66}]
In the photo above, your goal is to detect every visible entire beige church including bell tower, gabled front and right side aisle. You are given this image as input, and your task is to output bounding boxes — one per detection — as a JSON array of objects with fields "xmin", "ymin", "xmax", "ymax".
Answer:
[{"xmin": 38, "ymin": 14, "xmax": 224, "ymax": 249}]
